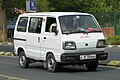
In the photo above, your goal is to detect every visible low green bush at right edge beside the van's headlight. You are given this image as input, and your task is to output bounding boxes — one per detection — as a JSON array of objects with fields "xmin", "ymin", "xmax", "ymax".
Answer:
[{"xmin": 107, "ymin": 36, "xmax": 120, "ymax": 45}]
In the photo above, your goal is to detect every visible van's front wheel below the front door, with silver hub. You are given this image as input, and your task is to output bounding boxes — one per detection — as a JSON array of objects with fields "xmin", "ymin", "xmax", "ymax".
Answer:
[{"xmin": 46, "ymin": 54, "xmax": 59, "ymax": 72}]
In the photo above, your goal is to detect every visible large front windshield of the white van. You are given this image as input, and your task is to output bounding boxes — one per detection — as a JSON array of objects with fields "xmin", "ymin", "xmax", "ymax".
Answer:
[{"xmin": 59, "ymin": 15, "xmax": 101, "ymax": 34}]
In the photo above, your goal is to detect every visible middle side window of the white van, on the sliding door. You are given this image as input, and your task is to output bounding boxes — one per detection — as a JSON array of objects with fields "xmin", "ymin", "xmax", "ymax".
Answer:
[{"xmin": 28, "ymin": 17, "xmax": 42, "ymax": 33}]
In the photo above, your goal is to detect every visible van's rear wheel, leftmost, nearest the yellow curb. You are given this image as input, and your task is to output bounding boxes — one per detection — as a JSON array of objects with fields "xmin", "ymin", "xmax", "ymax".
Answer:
[{"xmin": 19, "ymin": 51, "xmax": 30, "ymax": 68}]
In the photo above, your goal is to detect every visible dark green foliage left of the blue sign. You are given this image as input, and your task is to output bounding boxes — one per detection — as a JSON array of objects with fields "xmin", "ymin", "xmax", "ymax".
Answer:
[{"xmin": 2, "ymin": 0, "xmax": 26, "ymax": 18}]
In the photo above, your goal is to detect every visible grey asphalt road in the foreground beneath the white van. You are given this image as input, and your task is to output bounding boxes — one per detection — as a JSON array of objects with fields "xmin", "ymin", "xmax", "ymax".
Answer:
[{"xmin": 0, "ymin": 56, "xmax": 120, "ymax": 80}]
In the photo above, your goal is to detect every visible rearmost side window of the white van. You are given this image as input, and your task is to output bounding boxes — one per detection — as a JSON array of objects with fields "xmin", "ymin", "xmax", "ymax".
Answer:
[{"xmin": 17, "ymin": 17, "xmax": 28, "ymax": 32}]
